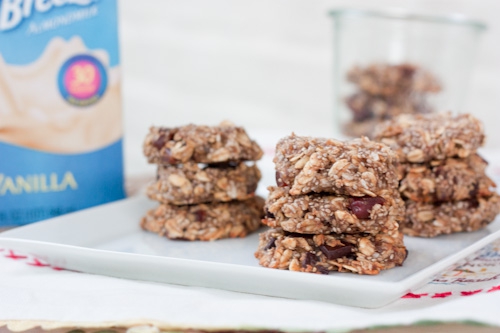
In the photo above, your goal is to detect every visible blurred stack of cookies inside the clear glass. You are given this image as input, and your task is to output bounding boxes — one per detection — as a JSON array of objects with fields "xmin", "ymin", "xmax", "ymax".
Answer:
[{"xmin": 345, "ymin": 64, "xmax": 441, "ymax": 136}]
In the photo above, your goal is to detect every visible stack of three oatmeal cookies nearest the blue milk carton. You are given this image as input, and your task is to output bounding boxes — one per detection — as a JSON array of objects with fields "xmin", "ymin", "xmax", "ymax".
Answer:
[{"xmin": 141, "ymin": 123, "xmax": 264, "ymax": 241}]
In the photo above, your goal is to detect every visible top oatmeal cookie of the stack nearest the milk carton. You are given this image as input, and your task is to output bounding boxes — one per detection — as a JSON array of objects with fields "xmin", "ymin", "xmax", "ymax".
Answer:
[{"xmin": 143, "ymin": 123, "xmax": 262, "ymax": 164}]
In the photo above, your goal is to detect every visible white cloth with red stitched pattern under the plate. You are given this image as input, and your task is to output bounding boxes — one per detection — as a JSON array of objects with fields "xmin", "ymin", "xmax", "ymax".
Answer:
[{"xmin": 0, "ymin": 240, "xmax": 500, "ymax": 332}]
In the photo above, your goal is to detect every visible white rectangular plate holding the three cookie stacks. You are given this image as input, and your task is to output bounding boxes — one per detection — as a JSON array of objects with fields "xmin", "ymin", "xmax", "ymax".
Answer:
[{"xmin": 0, "ymin": 196, "xmax": 500, "ymax": 308}]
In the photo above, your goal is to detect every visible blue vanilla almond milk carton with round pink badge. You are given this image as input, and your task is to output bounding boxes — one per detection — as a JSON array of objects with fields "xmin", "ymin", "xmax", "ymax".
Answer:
[{"xmin": 0, "ymin": 0, "xmax": 124, "ymax": 228}]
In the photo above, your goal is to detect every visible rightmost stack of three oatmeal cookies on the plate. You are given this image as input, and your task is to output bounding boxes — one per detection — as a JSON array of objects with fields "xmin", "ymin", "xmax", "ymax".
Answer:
[{"xmin": 375, "ymin": 113, "xmax": 500, "ymax": 237}]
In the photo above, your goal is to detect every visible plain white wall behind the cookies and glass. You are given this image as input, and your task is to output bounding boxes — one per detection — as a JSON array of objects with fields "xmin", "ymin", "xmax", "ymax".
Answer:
[{"xmin": 119, "ymin": 0, "xmax": 500, "ymax": 173}]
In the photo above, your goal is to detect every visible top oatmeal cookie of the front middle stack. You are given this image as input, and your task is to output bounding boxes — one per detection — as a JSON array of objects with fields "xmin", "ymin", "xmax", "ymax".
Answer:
[{"xmin": 274, "ymin": 134, "xmax": 398, "ymax": 197}]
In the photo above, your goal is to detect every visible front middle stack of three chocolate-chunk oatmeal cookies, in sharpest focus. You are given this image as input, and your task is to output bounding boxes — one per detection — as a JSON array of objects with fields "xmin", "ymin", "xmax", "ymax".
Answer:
[{"xmin": 255, "ymin": 134, "xmax": 406, "ymax": 274}]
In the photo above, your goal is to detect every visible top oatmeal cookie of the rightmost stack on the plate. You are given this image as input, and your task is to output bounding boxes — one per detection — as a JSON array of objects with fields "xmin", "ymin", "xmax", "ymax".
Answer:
[{"xmin": 374, "ymin": 113, "xmax": 484, "ymax": 163}]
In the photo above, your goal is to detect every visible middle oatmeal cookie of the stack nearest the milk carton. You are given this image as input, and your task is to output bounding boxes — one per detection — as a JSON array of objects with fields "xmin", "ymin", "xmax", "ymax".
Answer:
[{"xmin": 147, "ymin": 162, "xmax": 261, "ymax": 205}]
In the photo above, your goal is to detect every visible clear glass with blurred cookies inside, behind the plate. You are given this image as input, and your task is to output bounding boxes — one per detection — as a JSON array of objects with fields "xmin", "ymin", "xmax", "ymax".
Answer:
[{"xmin": 330, "ymin": 9, "xmax": 486, "ymax": 137}]
